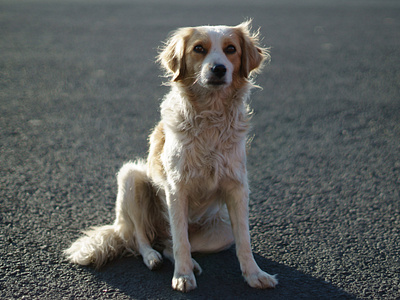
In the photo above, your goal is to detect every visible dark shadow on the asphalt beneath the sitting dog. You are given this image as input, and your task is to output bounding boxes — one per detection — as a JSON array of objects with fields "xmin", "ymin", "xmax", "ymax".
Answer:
[{"xmin": 92, "ymin": 247, "xmax": 356, "ymax": 299}]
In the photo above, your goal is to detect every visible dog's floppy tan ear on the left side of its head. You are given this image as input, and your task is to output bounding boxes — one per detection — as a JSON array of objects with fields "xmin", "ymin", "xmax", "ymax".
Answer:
[{"xmin": 158, "ymin": 28, "xmax": 192, "ymax": 81}]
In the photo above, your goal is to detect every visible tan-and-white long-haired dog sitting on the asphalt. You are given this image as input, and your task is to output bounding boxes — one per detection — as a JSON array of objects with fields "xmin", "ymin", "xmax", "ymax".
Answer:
[{"xmin": 65, "ymin": 20, "xmax": 278, "ymax": 292}]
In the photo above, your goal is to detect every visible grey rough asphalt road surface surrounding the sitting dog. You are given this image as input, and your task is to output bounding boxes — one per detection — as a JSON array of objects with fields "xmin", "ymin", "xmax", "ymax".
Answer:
[{"xmin": 0, "ymin": 0, "xmax": 400, "ymax": 299}]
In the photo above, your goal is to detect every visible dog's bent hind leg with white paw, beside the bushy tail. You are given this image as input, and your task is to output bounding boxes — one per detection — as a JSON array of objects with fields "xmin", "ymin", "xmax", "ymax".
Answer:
[{"xmin": 114, "ymin": 161, "xmax": 162, "ymax": 270}]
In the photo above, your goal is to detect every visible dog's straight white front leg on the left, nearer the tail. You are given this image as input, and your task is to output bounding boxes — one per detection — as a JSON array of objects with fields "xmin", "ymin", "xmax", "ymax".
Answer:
[{"xmin": 167, "ymin": 192, "xmax": 196, "ymax": 292}]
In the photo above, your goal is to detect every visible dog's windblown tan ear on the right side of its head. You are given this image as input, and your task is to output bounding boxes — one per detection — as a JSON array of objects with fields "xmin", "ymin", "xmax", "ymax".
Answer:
[{"xmin": 235, "ymin": 20, "xmax": 270, "ymax": 78}]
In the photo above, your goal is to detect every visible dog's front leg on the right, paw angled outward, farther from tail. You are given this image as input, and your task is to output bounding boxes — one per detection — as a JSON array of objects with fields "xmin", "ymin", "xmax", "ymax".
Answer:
[{"xmin": 226, "ymin": 184, "xmax": 278, "ymax": 289}]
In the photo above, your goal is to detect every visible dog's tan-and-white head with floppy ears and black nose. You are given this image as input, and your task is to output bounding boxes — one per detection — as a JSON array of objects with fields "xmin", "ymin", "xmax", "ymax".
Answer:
[{"xmin": 159, "ymin": 21, "xmax": 269, "ymax": 90}]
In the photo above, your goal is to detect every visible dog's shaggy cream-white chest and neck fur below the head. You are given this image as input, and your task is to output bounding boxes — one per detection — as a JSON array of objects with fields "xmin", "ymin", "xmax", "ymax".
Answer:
[{"xmin": 161, "ymin": 89, "xmax": 249, "ymax": 195}]
